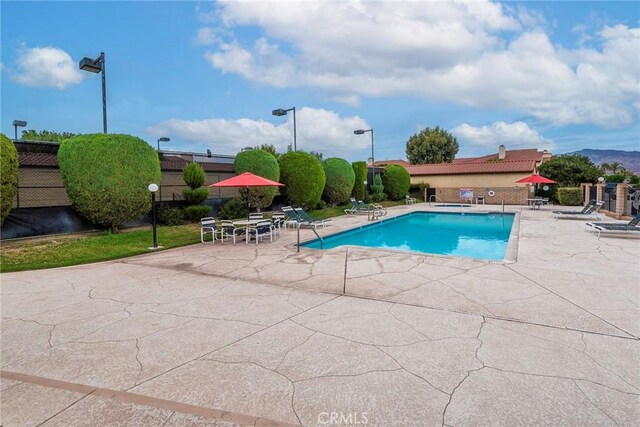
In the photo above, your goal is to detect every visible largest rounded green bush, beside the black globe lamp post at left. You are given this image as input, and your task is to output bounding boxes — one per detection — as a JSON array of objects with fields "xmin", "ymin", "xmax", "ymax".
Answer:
[{"xmin": 58, "ymin": 133, "xmax": 160, "ymax": 232}]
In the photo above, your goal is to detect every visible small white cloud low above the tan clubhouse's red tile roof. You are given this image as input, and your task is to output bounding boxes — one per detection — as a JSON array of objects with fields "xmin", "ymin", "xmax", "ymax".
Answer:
[{"xmin": 452, "ymin": 121, "xmax": 555, "ymax": 151}]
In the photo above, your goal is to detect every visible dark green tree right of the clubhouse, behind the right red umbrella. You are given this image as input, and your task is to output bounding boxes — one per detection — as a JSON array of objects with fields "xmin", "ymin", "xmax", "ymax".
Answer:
[{"xmin": 538, "ymin": 154, "xmax": 601, "ymax": 187}]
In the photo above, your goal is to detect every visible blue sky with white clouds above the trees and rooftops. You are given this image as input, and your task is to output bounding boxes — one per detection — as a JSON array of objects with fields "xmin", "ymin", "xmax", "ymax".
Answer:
[{"xmin": 0, "ymin": 1, "xmax": 640, "ymax": 161}]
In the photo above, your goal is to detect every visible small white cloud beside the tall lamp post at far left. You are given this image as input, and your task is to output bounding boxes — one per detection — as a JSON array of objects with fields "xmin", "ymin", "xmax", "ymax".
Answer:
[{"xmin": 14, "ymin": 47, "xmax": 83, "ymax": 89}]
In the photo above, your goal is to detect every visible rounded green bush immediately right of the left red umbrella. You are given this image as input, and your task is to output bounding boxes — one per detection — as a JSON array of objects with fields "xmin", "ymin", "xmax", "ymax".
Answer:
[{"xmin": 280, "ymin": 151, "xmax": 326, "ymax": 209}]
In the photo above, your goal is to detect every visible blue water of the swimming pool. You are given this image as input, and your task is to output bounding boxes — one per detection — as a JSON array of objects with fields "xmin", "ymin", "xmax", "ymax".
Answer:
[{"xmin": 303, "ymin": 212, "xmax": 514, "ymax": 260}]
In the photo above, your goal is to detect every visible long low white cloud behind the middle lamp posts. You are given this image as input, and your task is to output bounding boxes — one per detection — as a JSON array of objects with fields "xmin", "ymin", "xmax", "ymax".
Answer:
[{"xmin": 146, "ymin": 107, "xmax": 370, "ymax": 157}]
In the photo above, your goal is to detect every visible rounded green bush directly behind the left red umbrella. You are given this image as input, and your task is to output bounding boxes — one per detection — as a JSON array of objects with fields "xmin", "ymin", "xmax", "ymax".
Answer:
[{"xmin": 233, "ymin": 149, "xmax": 280, "ymax": 209}]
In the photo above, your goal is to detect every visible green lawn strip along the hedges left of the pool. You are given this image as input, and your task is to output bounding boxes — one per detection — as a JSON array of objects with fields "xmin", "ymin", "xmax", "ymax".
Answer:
[{"xmin": 0, "ymin": 201, "xmax": 404, "ymax": 273}]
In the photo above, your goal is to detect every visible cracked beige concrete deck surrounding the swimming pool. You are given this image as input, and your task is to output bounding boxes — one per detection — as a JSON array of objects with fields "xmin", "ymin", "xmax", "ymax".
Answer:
[{"xmin": 0, "ymin": 204, "xmax": 640, "ymax": 426}]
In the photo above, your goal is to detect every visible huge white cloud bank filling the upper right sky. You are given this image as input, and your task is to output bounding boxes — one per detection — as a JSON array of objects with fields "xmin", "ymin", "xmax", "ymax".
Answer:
[{"xmin": 206, "ymin": 0, "xmax": 640, "ymax": 126}]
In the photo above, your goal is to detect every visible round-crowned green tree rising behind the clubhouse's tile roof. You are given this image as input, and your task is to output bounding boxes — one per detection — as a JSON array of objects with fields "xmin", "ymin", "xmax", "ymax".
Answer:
[{"xmin": 406, "ymin": 126, "xmax": 459, "ymax": 165}]
